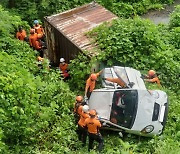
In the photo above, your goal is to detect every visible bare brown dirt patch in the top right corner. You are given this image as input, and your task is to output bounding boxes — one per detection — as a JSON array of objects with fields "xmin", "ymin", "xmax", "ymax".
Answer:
[{"xmin": 141, "ymin": 0, "xmax": 180, "ymax": 24}]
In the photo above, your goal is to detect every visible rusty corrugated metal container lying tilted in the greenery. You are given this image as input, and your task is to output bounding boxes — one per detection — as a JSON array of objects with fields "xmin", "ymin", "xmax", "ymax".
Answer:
[{"xmin": 45, "ymin": 2, "xmax": 117, "ymax": 63}]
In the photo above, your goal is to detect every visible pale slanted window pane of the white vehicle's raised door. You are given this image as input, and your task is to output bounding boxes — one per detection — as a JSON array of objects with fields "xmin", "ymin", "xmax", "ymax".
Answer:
[{"xmin": 113, "ymin": 66, "xmax": 129, "ymax": 84}]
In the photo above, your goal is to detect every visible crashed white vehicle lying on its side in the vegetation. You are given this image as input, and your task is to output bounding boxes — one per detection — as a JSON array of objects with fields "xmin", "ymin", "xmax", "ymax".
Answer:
[{"xmin": 88, "ymin": 66, "xmax": 168, "ymax": 136}]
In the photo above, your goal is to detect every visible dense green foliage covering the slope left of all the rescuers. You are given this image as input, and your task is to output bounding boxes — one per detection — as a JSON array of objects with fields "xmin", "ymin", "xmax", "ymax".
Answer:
[{"xmin": 0, "ymin": 5, "xmax": 77, "ymax": 153}]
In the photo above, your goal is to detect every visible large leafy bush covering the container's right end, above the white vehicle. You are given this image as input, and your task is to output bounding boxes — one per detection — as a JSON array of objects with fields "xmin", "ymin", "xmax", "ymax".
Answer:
[{"xmin": 87, "ymin": 18, "xmax": 180, "ymax": 90}]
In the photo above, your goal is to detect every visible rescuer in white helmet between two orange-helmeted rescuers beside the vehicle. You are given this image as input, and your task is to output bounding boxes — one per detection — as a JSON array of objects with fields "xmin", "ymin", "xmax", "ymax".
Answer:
[{"xmin": 77, "ymin": 105, "xmax": 89, "ymax": 146}]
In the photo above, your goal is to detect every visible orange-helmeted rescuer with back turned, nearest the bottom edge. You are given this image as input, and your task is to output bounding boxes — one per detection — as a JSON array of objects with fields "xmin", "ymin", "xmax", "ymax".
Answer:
[{"xmin": 85, "ymin": 110, "xmax": 104, "ymax": 151}]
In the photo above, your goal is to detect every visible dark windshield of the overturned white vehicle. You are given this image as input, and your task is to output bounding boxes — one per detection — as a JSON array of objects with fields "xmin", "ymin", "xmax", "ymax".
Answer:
[{"xmin": 110, "ymin": 90, "xmax": 138, "ymax": 129}]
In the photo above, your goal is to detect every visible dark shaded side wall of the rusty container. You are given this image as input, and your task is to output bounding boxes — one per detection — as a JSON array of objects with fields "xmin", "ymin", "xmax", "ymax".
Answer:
[{"xmin": 44, "ymin": 19, "xmax": 81, "ymax": 66}]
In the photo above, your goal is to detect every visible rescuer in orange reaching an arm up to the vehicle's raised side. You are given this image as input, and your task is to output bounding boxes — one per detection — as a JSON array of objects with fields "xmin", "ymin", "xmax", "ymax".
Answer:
[{"xmin": 85, "ymin": 70, "xmax": 103, "ymax": 99}]
